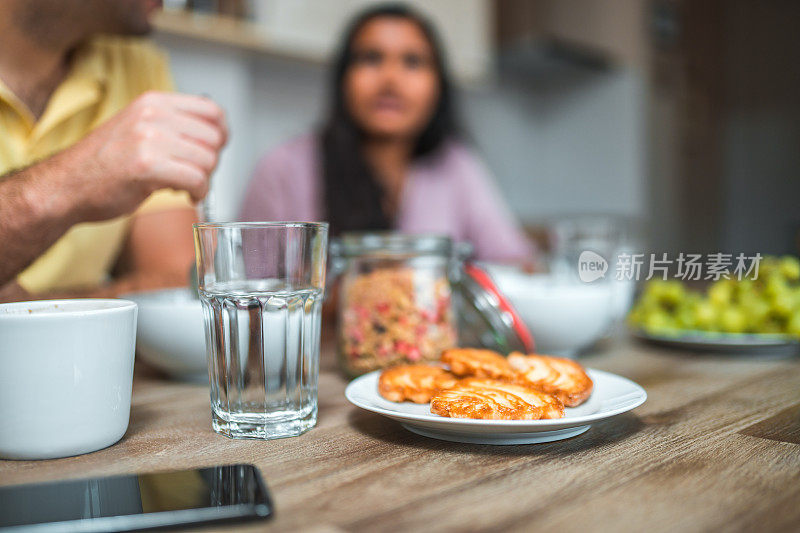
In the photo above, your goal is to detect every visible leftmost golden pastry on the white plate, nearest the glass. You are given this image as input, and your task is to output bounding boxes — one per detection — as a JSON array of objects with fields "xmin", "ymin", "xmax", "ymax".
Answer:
[{"xmin": 378, "ymin": 365, "xmax": 458, "ymax": 403}]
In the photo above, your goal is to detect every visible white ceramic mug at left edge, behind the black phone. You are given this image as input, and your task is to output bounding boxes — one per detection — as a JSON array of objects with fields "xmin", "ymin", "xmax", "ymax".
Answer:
[{"xmin": 0, "ymin": 299, "xmax": 137, "ymax": 459}]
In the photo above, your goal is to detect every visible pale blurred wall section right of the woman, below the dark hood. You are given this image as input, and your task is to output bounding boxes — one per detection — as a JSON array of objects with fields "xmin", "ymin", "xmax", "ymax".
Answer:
[{"xmin": 463, "ymin": 69, "xmax": 645, "ymax": 223}]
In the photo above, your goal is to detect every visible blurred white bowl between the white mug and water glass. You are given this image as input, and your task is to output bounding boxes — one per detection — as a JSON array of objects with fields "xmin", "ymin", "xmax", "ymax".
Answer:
[{"xmin": 125, "ymin": 288, "xmax": 208, "ymax": 381}]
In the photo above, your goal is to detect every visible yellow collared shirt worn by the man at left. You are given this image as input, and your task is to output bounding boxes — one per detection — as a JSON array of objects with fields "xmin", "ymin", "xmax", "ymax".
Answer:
[{"xmin": 0, "ymin": 37, "xmax": 192, "ymax": 294}]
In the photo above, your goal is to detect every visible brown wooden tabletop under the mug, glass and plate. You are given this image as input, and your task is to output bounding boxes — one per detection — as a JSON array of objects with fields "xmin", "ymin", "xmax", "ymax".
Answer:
[{"xmin": 0, "ymin": 334, "xmax": 800, "ymax": 532}]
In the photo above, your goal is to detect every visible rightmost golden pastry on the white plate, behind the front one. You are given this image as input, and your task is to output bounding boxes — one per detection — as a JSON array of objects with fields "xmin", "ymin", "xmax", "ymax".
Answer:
[{"xmin": 508, "ymin": 352, "xmax": 594, "ymax": 407}]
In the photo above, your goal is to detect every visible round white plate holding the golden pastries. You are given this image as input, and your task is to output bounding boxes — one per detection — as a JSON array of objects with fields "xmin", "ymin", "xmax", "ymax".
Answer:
[{"xmin": 345, "ymin": 369, "xmax": 647, "ymax": 444}]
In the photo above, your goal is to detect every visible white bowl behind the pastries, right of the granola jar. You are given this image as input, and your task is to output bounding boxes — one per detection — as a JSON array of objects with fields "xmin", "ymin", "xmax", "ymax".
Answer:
[{"xmin": 487, "ymin": 266, "xmax": 616, "ymax": 357}]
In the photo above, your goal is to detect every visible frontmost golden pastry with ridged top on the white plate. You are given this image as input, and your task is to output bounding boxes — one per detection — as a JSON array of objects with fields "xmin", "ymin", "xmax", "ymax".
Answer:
[{"xmin": 431, "ymin": 378, "xmax": 564, "ymax": 420}]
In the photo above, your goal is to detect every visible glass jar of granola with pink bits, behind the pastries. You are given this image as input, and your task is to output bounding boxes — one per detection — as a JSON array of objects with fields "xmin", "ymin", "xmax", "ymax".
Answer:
[{"xmin": 331, "ymin": 233, "xmax": 457, "ymax": 377}]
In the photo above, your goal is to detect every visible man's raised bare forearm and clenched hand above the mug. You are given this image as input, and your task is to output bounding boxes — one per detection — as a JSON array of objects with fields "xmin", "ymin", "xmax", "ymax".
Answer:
[{"xmin": 0, "ymin": 92, "xmax": 227, "ymax": 287}]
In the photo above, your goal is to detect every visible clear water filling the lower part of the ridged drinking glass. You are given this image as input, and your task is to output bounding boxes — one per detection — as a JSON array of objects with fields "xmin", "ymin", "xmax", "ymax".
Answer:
[{"xmin": 200, "ymin": 280, "xmax": 322, "ymax": 439}]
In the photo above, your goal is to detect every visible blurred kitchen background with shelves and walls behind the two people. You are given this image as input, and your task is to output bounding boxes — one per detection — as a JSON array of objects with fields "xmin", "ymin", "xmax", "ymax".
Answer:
[{"xmin": 155, "ymin": 0, "xmax": 800, "ymax": 254}]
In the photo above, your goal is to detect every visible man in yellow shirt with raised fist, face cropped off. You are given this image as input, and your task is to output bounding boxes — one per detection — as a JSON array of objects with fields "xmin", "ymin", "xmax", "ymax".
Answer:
[{"xmin": 0, "ymin": 0, "xmax": 227, "ymax": 301}]
